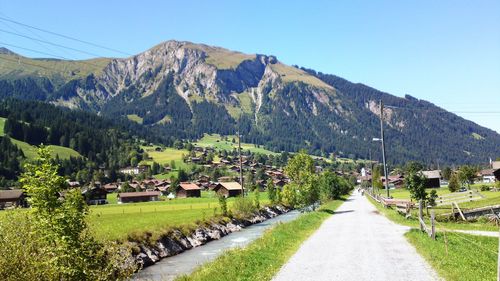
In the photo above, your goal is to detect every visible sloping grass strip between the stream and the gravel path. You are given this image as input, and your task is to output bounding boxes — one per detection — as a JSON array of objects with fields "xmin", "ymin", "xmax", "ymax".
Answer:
[{"xmin": 177, "ymin": 200, "xmax": 343, "ymax": 281}]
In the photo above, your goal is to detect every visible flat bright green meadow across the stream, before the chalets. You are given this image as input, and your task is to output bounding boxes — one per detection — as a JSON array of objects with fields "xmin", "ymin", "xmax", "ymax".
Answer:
[{"xmin": 89, "ymin": 192, "xmax": 269, "ymax": 240}]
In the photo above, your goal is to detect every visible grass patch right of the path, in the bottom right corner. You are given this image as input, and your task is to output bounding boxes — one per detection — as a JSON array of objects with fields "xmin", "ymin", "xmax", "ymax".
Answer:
[{"xmin": 405, "ymin": 230, "xmax": 498, "ymax": 281}]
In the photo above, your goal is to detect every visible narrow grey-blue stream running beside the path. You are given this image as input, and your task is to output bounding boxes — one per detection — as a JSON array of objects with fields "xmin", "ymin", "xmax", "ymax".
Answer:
[{"xmin": 132, "ymin": 210, "xmax": 300, "ymax": 281}]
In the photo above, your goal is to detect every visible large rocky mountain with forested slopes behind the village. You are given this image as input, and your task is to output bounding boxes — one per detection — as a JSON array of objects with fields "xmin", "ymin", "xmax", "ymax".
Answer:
[{"xmin": 0, "ymin": 41, "xmax": 500, "ymax": 164}]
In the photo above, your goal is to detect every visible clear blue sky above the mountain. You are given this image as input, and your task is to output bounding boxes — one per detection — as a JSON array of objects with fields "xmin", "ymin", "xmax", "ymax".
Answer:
[{"xmin": 0, "ymin": 0, "xmax": 500, "ymax": 132}]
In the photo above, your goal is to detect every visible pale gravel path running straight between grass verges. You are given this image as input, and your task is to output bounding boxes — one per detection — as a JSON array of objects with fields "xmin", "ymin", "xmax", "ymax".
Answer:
[{"xmin": 273, "ymin": 192, "xmax": 440, "ymax": 281}]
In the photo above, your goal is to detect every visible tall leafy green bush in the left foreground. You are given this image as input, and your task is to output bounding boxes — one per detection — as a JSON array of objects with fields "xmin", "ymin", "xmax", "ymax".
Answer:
[{"xmin": 10, "ymin": 146, "xmax": 134, "ymax": 280}]
